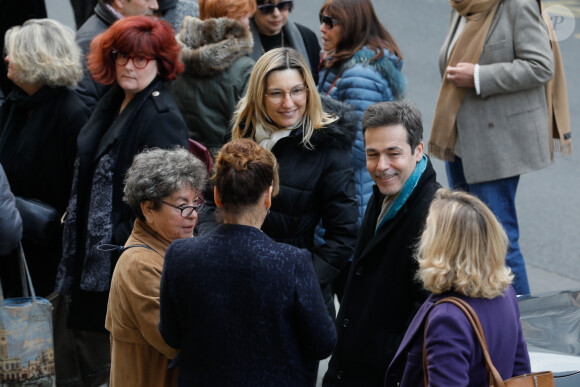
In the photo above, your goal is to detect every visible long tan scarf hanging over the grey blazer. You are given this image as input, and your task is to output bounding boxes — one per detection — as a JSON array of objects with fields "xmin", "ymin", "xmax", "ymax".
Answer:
[{"xmin": 429, "ymin": 0, "xmax": 500, "ymax": 161}]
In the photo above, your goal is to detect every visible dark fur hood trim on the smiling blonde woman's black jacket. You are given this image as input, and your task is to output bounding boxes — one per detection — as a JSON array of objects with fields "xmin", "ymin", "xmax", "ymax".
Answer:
[{"xmin": 310, "ymin": 96, "xmax": 359, "ymax": 150}]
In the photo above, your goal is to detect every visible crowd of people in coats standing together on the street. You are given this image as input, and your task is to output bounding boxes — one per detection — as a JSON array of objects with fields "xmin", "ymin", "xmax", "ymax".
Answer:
[{"xmin": 0, "ymin": 0, "xmax": 570, "ymax": 387}]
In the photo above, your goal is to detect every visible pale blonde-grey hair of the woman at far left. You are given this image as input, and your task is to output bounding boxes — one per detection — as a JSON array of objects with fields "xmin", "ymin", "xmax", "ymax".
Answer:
[{"xmin": 4, "ymin": 19, "xmax": 83, "ymax": 87}]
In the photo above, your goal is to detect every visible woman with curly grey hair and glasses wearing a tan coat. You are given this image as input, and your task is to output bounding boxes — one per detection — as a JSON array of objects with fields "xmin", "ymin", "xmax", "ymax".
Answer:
[{"xmin": 105, "ymin": 147, "xmax": 207, "ymax": 387}]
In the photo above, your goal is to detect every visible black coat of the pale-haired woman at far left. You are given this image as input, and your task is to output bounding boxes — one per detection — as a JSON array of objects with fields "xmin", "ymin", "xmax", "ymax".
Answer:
[{"xmin": 0, "ymin": 86, "xmax": 89, "ymax": 296}]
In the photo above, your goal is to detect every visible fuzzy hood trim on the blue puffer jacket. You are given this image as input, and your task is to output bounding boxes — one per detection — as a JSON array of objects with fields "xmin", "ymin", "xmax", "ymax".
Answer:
[{"xmin": 339, "ymin": 48, "xmax": 407, "ymax": 99}]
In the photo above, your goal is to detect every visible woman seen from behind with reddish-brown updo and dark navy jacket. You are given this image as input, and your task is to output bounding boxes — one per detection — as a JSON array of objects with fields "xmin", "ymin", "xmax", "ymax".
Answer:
[{"xmin": 159, "ymin": 139, "xmax": 336, "ymax": 386}]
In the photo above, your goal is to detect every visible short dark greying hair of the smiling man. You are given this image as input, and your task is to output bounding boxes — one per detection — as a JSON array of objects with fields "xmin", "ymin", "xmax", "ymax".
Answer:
[{"xmin": 362, "ymin": 100, "xmax": 423, "ymax": 153}]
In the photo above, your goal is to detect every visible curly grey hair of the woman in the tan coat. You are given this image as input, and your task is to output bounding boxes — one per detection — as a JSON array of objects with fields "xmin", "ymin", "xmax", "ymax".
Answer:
[{"xmin": 123, "ymin": 146, "xmax": 207, "ymax": 220}]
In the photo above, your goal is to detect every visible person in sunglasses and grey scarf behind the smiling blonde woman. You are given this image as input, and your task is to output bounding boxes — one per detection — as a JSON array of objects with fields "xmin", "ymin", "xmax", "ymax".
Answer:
[{"xmin": 250, "ymin": 0, "xmax": 320, "ymax": 83}]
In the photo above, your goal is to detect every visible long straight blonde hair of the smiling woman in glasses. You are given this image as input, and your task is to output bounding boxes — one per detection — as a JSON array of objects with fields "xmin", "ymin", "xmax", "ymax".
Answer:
[{"xmin": 232, "ymin": 47, "xmax": 338, "ymax": 149}]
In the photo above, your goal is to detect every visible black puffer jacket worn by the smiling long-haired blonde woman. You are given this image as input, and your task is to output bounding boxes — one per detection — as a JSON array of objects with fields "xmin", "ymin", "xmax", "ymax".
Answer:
[{"xmin": 198, "ymin": 97, "xmax": 358, "ymax": 311}]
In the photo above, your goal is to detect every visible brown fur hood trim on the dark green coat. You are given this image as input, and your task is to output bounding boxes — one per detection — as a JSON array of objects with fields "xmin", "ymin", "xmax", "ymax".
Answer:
[{"xmin": 177, "ymin": 16, "xmax": 254, "ymax": 78}]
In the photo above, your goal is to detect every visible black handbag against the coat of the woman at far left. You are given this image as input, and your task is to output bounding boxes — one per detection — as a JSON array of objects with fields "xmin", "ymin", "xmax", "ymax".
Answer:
[{"xmin": 16, "ymin": 196, "xmax": 60, "ymax": 245}]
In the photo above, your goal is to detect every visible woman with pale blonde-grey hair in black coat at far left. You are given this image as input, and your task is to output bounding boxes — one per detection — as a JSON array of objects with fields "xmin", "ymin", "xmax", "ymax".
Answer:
[{"xmin": 0, "ymin": 19, "xmax": 89, "ymax": 296}]
